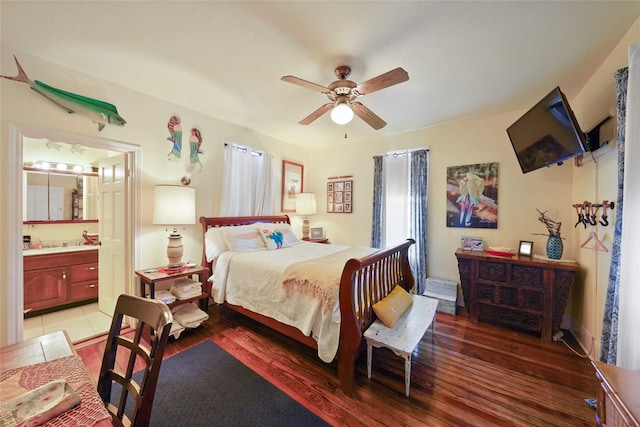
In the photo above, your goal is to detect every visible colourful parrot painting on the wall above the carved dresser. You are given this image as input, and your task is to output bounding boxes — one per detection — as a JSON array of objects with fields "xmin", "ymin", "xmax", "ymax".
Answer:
[{"xmin": 446, "ymin": 162, "xmax": 498, "ymax": 228}]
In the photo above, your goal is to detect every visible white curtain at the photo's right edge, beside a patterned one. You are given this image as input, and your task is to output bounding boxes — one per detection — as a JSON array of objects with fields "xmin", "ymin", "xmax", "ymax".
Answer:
[{"xmin": 617, "ymin": 44, "xmax": 640, "ymax": 369}]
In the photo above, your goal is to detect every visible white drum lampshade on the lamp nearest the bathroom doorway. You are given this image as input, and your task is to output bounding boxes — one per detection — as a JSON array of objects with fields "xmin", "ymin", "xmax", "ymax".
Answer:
[{"xmin": 153, "ymin": 185, "xmax": 196, "ymax": 225}]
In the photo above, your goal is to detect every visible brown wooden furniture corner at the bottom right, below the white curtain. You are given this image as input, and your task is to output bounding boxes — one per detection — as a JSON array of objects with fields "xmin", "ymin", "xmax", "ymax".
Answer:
[{"xmin": 591, "ymin": 361, "xmax": 640, "ymax": 427}]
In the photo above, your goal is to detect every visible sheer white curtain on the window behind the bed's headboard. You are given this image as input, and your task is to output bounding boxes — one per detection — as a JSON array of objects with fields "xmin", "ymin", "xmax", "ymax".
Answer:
[{"xmin": 219, "ymin": 143, "xmax": 275, "ymax": 216}]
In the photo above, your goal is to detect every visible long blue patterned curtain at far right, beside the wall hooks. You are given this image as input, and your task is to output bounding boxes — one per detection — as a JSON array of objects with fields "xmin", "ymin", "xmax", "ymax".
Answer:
[{"xmin": 600, "ymin": 67, "xmax": 629, "ymax": 365}]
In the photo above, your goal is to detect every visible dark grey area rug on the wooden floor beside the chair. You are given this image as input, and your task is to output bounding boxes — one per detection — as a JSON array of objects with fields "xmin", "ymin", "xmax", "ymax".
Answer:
[{"xmin": 112, "ymin": 341, "xmax": 328, "ymax": 427}]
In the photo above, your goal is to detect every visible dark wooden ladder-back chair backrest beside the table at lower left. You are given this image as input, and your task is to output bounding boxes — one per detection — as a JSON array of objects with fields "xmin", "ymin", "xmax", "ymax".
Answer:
[{"xmin": 98, "ymin": 295, "xmax": 173, "ymax": 426}]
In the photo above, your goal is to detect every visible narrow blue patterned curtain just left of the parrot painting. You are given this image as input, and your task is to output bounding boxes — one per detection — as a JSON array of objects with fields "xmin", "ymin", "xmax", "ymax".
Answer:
[{"xmin": 409, "ymin": 150, "xmax": 429, "ymax": 295}]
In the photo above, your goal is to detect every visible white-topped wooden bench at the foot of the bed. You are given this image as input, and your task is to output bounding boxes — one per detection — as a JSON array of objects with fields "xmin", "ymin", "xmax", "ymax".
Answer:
[{"xmin": 364, "ymin": 295, "xmax": 438, "ymax": 397}]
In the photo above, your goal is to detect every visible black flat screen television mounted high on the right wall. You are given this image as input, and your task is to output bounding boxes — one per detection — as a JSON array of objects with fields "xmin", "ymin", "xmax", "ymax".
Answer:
[{"xmin": 507, "ymin": 87, "xmax": 586, "ymax": 173}]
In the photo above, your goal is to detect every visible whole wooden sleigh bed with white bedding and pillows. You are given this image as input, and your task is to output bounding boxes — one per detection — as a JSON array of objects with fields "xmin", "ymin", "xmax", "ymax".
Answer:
[{"xmin": 200, "ymin": 215, "xmax": 414, "ymax": 397}]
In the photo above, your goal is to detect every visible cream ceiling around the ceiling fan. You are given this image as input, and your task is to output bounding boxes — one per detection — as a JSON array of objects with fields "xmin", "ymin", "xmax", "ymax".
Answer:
[{"xmin": 0, "ymin": 1, "xmax": 640, "ymax": 148}]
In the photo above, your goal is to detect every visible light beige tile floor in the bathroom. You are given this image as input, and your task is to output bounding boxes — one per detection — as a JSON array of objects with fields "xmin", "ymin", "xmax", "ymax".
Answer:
[{"xmin": 23, "ymin": 303, "xmax": 111, "ymax": 342}]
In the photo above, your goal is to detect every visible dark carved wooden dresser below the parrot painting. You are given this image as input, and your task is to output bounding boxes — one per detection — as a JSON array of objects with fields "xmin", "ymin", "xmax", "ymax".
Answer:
[{"xmin": 456, "ymin": 249, "xmax": 578, "ymax": 341}]
